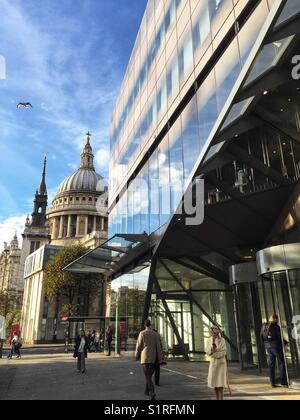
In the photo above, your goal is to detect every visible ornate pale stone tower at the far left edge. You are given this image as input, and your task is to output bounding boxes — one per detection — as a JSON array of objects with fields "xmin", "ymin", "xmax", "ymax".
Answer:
[{"xmin": 0, "ymin": 234, "xmax": 23, "ymax": 313}]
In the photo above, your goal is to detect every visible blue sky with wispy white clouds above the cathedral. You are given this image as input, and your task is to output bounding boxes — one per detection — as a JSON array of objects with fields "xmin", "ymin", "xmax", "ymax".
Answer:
[{"xmin": 0, "ymin": 0, "xmax": 147, "ymax": 250}]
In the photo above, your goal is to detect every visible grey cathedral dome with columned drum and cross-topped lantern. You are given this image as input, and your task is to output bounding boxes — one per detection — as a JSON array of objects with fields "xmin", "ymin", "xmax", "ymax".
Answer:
[{"xmin": 47, "ymin": 133, "xmax": 108, "ymax": 248}]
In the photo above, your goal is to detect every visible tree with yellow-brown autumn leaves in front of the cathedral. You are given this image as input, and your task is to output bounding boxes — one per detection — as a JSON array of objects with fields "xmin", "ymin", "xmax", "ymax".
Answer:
[{"xmin": 45, "ymin": 245, "xmax": 102, "ymax": 316}]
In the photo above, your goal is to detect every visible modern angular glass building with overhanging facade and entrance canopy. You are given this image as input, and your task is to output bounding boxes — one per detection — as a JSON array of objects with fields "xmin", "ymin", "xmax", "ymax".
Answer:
[{"xmin": 66, "ymin": 0, "xmax": 300, "ymax": 386}]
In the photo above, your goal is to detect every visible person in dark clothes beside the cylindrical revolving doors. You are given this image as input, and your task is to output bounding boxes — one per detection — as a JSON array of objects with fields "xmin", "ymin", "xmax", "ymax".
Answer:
[{"xmin": 261, "ymin": 314, "xmax": 288, "ymax": 388}]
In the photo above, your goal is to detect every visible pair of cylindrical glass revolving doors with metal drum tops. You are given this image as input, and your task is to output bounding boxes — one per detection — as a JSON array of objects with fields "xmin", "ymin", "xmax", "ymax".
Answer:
[{"xmin": 230, "ymin": 243, "xmax": 300, "ymax": 388}]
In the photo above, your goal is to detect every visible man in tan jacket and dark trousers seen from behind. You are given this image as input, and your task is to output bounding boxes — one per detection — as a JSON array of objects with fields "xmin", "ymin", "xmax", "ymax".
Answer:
[{"xmin": 135, "ymin": 320, "xmax": 163, "ymax": 400}]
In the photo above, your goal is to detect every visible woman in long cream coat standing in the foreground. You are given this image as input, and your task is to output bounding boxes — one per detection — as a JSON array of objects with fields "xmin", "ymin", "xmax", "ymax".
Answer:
[{"xmin": 206, "ymin": 327, "xmax": 228, "ymax": 401}]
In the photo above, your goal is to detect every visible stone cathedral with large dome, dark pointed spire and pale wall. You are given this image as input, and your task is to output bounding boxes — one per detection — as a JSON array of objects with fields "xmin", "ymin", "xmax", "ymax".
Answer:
[{"xmin": 21, "ymin": 133, "xmax": 108, "ymax": 344}]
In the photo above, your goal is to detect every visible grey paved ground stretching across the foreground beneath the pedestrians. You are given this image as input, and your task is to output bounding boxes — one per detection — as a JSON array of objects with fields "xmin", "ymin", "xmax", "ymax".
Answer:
[{"xmin": 0, "ymin": 346, "xmax": 300, "ymax": 401}]
